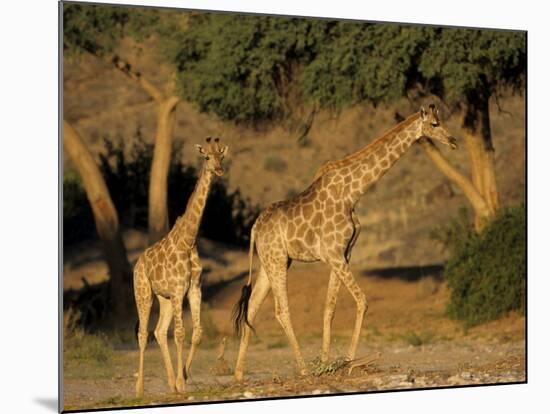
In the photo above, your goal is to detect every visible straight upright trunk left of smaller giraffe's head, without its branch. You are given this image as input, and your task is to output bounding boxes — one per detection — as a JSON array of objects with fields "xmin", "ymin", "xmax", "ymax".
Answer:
[{"xmin": 149, "ymin": 96, "xmax": 179, "ymax": 245}]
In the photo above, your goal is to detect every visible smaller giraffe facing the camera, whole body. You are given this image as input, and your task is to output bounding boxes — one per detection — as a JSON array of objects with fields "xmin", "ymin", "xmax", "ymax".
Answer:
[{"xmin": 134, "ymin": 138, "xmax": 227, "ymax": 397}]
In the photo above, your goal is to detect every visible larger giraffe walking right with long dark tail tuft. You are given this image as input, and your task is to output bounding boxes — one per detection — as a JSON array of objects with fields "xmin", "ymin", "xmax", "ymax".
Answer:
[{"xmin": 234, "ymin": 105, "xmax": 457, "ymax": 380}]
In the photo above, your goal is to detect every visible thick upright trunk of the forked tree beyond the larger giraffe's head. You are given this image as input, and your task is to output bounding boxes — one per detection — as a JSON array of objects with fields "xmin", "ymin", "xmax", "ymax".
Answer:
[{"xmin": 462, "ymin": 94, "xmax": 499, "ymax": 228}]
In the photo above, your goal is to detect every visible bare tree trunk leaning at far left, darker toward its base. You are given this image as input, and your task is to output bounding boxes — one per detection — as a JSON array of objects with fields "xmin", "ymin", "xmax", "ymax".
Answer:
[{"xmin": 63, "ymin": 121, "xmax": 133, "ymax": 315}]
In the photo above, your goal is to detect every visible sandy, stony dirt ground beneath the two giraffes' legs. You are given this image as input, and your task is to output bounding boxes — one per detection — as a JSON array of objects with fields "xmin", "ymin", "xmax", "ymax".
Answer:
[{"xmin": 64, "ymin": 264, "xmax": 526, "ymax": 410}]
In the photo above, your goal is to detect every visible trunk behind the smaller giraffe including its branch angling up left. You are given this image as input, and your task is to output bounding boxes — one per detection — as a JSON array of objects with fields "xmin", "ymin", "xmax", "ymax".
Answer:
[{"xmin": 112, "ymin": 55, "xmax": 181, "ymax": 245}]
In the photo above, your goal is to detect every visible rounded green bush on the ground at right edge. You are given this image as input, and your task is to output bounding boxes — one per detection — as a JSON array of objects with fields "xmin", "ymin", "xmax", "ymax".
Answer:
[{"xmin": 444, "ymin": 204, "xmax": 526, "ymax": 326}]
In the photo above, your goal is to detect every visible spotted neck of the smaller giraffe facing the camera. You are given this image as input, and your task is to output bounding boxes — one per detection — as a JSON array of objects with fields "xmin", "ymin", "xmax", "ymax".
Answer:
[{"xmin": 175, "ymin": 165, "xmax": 213, "ymax": 247}]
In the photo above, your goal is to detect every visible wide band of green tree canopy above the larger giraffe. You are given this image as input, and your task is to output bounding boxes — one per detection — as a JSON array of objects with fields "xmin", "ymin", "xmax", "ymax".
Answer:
[{"xmin": 171, "ymin": 13, "xmax": 526, "ymax": 122}]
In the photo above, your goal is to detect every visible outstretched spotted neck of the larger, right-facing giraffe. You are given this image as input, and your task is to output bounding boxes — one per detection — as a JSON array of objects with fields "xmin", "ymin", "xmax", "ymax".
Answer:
[{"xmin": 342, "ymin": 114, "xmax": 422, "ymax": 204}]
